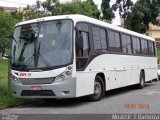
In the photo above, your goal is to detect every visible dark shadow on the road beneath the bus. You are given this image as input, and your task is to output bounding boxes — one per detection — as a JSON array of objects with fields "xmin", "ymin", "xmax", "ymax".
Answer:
[{"xmin": 25, "ymin": 83, "xmax": 157, "ymax": 108}]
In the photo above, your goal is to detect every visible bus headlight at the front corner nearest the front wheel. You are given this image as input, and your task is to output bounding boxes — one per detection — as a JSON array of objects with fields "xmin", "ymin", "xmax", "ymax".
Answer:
[{"xmin": 54, "ymin": 65, "xmax": 72, "ymax": 82}]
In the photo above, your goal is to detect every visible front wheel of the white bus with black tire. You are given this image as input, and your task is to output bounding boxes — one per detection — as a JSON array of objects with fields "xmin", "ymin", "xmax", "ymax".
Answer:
[{"xmin": 89, "ymin": 76, "xmax": 105, "ymax": 101}]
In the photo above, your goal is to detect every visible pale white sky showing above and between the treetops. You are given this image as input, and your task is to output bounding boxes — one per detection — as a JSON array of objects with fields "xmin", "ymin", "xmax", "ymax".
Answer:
[{"xmin": 0, "ymin": 0, "xmax": 137, "ymax": 25}]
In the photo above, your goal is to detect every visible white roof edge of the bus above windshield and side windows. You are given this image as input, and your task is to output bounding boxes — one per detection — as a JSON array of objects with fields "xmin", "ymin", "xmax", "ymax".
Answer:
[{"xmin": 16, "ymin": 14, "xmax": 155, "ymax": 41}]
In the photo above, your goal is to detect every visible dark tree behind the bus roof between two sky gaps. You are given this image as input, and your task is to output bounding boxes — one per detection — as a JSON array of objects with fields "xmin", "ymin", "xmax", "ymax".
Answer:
[{"xmin": 101, "ymin": 0, "xmax": 115, "ymax": 21}]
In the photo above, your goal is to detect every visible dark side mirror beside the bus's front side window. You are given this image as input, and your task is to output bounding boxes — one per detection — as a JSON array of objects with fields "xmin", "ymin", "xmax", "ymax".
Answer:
[{"xmin": 76, "ymin": 30, "xmax": 83, "ymax": 49}]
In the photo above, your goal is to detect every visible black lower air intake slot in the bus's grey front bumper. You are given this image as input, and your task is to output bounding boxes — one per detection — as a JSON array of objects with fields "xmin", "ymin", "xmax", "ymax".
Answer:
[{"xmin": 21, "ymin": 90, "xmax": 55, "ymax": 96}]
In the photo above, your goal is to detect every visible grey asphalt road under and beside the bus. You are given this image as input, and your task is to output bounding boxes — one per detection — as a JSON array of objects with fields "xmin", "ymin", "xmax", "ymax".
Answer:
[{"xmin": 0, "ymin": 82, "xmax": 160, "ymax": 119}]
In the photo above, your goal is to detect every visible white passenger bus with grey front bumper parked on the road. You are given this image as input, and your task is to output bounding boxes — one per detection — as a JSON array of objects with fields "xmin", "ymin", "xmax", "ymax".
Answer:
[{"xmin": 11, "ymin": 15, "xmax": 157, "ymax": 101}]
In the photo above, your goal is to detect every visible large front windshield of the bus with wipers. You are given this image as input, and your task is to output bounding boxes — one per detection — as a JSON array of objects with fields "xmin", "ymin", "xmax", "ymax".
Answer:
[{"xmin": 11, "ymin": 20, "xmax": 73, "ymax": 69}]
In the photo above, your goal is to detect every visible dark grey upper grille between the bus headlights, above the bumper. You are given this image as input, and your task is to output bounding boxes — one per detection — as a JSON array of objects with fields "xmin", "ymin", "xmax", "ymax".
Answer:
[{"xmin": 19, "ymin": 77, "xmax": 55, "ymax": 85}]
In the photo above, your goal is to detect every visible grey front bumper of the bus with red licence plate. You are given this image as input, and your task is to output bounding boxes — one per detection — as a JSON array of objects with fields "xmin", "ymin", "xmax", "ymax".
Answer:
[{"xmin": 11, "ymin": 78, "xmax": 76, "ymax": 98}]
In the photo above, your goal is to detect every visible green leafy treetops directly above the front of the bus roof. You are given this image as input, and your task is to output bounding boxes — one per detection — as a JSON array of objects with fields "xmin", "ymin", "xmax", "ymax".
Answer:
[{"xmin": 25, "ymin": 0, "xmax": 100, "ymax": 20}]
